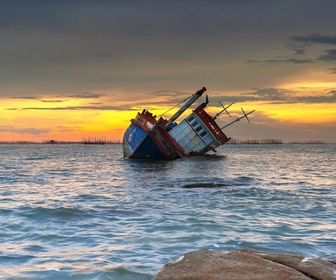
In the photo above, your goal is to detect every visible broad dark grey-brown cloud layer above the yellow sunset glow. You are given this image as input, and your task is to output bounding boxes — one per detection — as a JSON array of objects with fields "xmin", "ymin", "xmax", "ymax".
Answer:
[{"xmin": 0, "ymin": 0, "xmax": 336, "ymax": 100}]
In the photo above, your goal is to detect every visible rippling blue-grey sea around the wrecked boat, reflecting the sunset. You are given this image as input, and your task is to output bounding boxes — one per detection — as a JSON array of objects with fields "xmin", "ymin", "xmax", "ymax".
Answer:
[{"xmin": 0, "ymin": 144, "xmax": 336, "ymax": 280}]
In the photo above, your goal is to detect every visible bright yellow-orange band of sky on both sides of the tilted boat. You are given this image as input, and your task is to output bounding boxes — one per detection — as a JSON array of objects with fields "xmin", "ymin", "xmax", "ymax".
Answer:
[{"xmin": 0, "ymin": 83, "xmax": 336, "ymax": 142}]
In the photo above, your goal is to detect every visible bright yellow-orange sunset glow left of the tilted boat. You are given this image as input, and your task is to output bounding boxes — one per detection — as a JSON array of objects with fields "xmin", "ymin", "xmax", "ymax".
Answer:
[{"xmin": 0, "ymin": 94, "xmax": 173, "ymax": 142}]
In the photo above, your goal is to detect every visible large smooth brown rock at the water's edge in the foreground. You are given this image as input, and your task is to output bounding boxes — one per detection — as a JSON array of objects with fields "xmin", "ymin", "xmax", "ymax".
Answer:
[{"xmin": 153, "ymin": 250, "xmax": 336, "ymax": 280}]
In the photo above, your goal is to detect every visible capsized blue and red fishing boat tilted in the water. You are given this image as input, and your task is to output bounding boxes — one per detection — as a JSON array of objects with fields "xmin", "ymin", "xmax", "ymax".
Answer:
[{"xmin": 123, "ymin": 87, "xmax": 254, "ymax": 159}]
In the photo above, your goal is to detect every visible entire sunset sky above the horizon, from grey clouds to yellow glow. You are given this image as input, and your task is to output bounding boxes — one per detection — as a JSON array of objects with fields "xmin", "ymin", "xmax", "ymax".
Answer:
[{"xmin": 0, "ymin": 0, "xmax": 336, "ymax": 143}]
